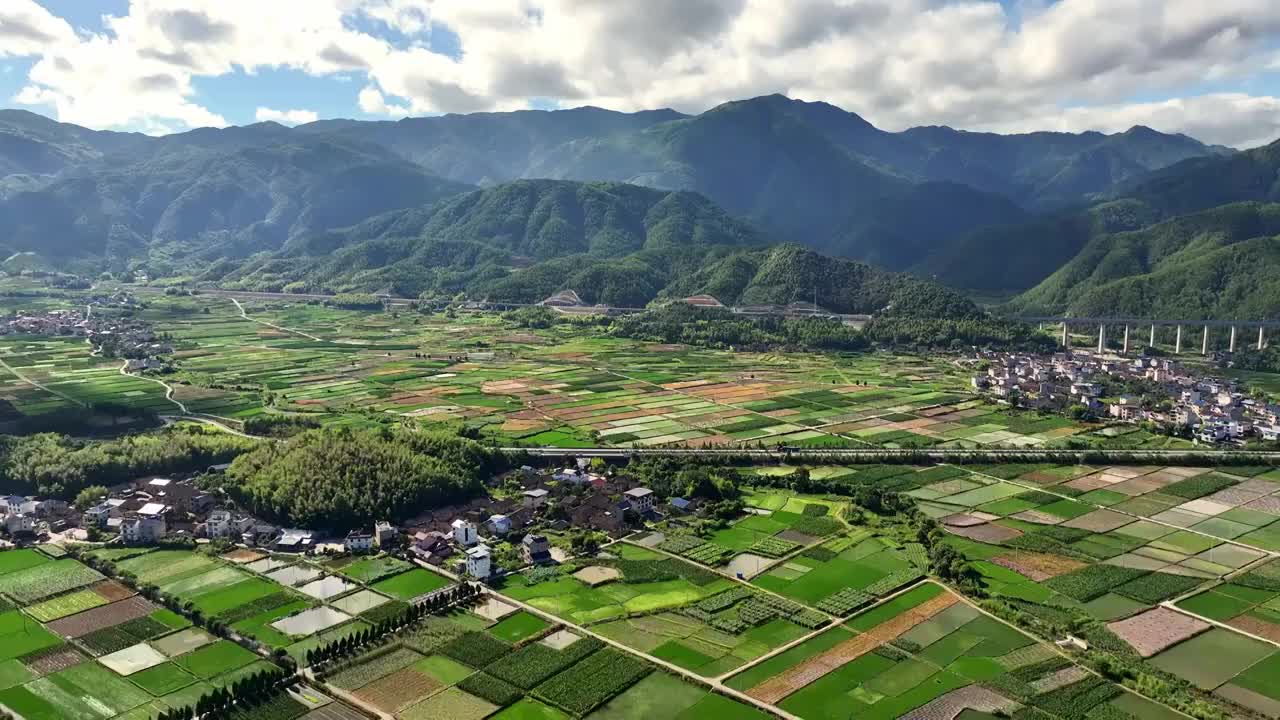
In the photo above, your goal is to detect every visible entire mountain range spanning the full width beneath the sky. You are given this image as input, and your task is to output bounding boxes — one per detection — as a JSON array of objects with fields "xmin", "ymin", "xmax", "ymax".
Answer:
[{"xmin": 0, "ymin": 96, "xmax": 1280, "ymax": 313}]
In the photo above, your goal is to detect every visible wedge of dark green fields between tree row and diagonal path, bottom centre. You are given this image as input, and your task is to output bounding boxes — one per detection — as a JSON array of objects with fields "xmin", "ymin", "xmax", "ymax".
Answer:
[{"xmin": 311, "ymin": 589, "xmax": 764, "ymax": 720}]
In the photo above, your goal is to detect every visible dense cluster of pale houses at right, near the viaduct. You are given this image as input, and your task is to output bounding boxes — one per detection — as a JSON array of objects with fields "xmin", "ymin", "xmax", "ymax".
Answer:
[{"xmin": 972, "ymin": 352, "xmax": 1280, "ymax": 443}]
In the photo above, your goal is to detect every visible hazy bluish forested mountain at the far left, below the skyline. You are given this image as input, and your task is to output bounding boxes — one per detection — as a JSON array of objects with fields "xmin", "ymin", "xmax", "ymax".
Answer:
[{"xmin": 0, "ymin": 136, "xmax": 468, "ymax": 275}]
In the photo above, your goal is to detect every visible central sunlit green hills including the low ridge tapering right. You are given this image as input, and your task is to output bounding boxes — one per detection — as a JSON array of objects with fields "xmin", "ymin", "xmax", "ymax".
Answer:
[{"xmin": 215, "ymin": 181, "xmax": 973, "ymax": 313}]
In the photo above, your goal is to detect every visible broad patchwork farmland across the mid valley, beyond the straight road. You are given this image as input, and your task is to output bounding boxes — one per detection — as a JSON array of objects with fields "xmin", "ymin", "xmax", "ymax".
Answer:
[{"xmin": 0, "ymin": 286, "xmax": 1149, "ymax": 447}]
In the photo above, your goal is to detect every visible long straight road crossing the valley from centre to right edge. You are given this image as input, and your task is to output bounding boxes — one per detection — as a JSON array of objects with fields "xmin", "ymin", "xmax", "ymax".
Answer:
[{"xmin": 502, "ymin": 447, "xmax": 1280, "ymax": 465}]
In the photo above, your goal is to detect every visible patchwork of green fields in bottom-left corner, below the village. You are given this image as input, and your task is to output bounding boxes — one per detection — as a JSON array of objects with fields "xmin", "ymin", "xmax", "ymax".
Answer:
[{"xmin": 0, "ymin": 548, "xmax": 460, "ymax": 720}]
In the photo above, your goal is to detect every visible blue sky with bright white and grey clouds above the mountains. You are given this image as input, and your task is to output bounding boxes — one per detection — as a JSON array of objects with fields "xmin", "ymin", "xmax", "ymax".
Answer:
[{"xmin": 0, "ymin": 0, "xmax": 1280, "ymax": 147}]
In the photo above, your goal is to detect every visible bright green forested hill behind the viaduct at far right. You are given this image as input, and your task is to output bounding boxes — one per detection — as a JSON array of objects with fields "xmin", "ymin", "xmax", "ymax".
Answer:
[{"xmin": 1011, "ymin": 202, "xmax": 1280, "ymax": 319}]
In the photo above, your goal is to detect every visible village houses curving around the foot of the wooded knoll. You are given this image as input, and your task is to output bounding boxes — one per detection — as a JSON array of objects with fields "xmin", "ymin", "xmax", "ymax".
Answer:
[{"xmin": 0, "ymin": 460, "xmax": 675, "ymax": 580}]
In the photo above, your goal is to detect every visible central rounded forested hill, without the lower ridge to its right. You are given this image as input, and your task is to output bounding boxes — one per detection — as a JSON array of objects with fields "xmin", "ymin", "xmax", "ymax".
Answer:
[{"xmin": 215, "ymin": 181, "xmax": 767, "ymax": 305}]
